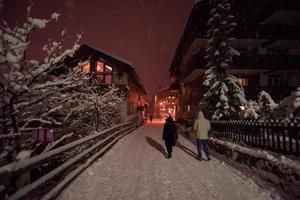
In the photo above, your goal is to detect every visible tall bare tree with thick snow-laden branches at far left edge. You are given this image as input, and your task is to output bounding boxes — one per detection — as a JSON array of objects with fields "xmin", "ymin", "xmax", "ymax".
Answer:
[{"xmin": 0, "ymin": 1, "xmax": 80, "ymax": 163}]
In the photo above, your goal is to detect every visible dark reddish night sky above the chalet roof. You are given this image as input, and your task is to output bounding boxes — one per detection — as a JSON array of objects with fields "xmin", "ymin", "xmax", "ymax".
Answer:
[{"xmin": 1, "ymin": 0, "xmax": 194, "ymax": 95}]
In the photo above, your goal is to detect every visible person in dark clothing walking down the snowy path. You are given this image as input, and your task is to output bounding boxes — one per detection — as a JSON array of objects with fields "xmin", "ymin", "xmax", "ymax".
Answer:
[{"xmin": 162, "ymin": 116, "xmax": 178, "ymax": 158}]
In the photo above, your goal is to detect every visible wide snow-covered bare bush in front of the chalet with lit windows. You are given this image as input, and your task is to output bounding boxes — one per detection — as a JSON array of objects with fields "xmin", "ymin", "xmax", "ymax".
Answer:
[{"xmin": 27, "ymin": 73, "xmax": 124, "ymax": 134}]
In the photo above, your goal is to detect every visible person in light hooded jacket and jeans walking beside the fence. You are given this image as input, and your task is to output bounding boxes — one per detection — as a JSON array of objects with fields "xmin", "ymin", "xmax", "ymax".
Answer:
[{"xmin": 194, "ymin": 111, "xmax": 210, "ymax": 160}]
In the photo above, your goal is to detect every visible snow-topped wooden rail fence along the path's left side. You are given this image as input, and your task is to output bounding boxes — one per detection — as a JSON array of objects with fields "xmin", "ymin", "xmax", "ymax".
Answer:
[{"xmin": 0, "ymin": 122, "xmax": 135, "ymax": 200}]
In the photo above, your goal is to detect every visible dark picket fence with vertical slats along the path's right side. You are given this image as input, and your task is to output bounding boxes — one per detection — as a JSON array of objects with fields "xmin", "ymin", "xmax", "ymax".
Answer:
[{"xmin": 211, "ymin": 121, "xmax": 300, "ymax": 155}]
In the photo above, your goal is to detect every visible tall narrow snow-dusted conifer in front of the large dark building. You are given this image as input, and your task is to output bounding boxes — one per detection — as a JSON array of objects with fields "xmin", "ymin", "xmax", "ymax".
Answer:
[{"xmin": 202, "ymin": 0, "xmax": 246, "ymax": 119}]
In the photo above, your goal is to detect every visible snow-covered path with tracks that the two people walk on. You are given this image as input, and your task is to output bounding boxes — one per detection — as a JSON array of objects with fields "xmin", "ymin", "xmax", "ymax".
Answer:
[{"xmin": 58, "ymin": 123, "xmax": 279, "ymax": 200}]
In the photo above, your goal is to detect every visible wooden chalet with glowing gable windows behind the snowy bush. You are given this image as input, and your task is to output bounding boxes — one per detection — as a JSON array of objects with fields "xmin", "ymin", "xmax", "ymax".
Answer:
[{"xmin": 56, "ymin": 44, "xmax": 147, "ymax": 122}]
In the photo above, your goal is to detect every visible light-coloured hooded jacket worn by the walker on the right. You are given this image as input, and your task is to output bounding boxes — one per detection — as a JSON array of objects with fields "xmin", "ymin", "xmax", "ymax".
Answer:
[{"xmin": 194, "ymin": 111, "xmax": 210, "ymax": 140}]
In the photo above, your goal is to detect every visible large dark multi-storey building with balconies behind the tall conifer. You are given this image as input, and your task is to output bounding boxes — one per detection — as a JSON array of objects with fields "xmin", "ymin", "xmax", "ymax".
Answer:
[{"xmin": 169, "ymin": 0, "xmax": 300, "ymax": 120}]
